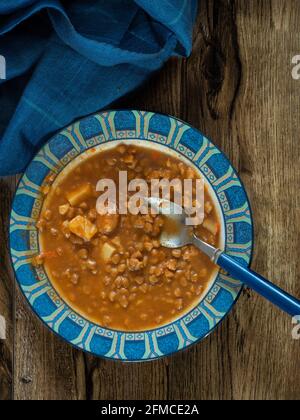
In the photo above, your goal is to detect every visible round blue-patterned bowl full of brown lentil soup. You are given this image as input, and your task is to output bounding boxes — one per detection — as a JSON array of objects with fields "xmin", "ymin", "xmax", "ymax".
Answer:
[{"xmin": 10, "ymin": 111, "xmax": 252, "ymax": 361}]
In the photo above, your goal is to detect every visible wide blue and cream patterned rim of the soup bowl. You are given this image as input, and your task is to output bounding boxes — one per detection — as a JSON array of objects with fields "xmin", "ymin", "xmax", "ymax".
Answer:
[{"xmin": 10, "ymin": 110, "xmax": 253, "ymax": 361}]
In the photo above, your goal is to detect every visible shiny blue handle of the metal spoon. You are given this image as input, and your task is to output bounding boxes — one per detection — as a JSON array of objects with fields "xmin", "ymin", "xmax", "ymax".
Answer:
[{"xmin": 216, "ymin": 253, "xmax": 300, "ymax": 316}]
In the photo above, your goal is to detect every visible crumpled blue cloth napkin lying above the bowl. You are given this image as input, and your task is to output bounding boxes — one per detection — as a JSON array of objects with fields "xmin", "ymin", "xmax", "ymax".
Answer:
[{"xmin": 0, "ymin": 0, "xmax": 197, "ymax": 175}]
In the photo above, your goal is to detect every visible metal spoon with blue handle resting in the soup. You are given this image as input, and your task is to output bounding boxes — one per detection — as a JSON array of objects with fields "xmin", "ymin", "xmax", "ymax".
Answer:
[{"xmin": 146, "ymin": 197, "xmax": 300, "ymax": 316}]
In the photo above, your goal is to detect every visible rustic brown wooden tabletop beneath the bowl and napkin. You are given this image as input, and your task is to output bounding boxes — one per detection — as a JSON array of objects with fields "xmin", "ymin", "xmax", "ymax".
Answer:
[{"xmin": 0, "ymin": 0, "xmax": 300, "ymax": 400}]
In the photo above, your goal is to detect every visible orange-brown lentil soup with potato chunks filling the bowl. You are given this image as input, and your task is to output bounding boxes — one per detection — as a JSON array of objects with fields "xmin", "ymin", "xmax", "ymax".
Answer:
[{"xmin": 33, "ymin": 144, "xmax": 220, "ymax": 331}]
